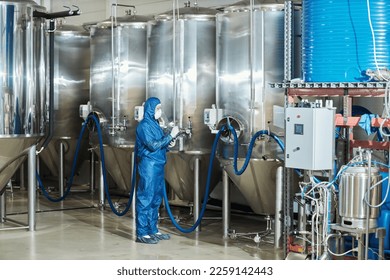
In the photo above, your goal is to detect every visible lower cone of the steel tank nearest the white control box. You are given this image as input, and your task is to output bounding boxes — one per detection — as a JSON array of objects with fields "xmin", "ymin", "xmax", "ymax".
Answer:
[{"xmin": 220, "ymin": 158, "xmax": 283, "ymax": 215}]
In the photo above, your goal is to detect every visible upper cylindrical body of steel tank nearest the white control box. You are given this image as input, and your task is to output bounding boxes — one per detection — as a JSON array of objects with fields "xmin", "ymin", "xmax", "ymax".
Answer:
[{"xmin": 217, "ymin": 4, "xmax": 284, "ymax": 143}]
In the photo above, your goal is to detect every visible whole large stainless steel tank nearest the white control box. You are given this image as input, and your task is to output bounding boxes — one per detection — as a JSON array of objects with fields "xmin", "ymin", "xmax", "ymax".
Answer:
[{"xmin": 216, "ymin": 1, "xmax": 299, "ymax": 215}]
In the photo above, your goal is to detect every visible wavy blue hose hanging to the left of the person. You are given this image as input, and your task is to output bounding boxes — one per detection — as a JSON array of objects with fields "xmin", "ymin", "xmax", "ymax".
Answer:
[{"xmin": 36, "ymin": 115, "xmax": 136, "ymax": 216}]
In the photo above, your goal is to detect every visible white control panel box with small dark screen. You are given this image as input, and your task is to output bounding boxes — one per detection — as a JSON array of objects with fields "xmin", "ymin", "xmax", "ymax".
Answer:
[{"xmin": 285, "ymin": 107, "xmax": 335, "ymax": 170}]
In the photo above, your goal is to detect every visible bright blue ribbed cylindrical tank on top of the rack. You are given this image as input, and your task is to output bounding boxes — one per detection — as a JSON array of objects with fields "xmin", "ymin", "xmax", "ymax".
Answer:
[{"xmin": 302, "ymin": 0, "xmax": 390, "ymax": 82}]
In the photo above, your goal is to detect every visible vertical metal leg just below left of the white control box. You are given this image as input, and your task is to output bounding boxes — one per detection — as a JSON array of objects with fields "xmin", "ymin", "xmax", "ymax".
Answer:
[{"xmin": 274, "ymin": 166, "xmax": 283, "ymax": 249}]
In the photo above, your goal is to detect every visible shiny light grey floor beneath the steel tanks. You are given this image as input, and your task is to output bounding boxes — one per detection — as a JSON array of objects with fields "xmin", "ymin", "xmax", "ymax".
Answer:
[{"xmin": 0, "ymin": 186, "xmax": 283, "ymax": 260}]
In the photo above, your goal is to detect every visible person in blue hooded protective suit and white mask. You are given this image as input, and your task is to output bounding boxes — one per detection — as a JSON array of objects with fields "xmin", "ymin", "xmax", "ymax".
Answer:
[{"xmin": 136, "ymin": 97, "xmax": 179, "ymax": 244}]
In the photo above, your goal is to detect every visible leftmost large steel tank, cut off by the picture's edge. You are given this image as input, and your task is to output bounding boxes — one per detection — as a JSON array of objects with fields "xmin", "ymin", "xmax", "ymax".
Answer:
[{"xmin": 0, "ymin": 0, "xmax": 48, "ymax": 193}]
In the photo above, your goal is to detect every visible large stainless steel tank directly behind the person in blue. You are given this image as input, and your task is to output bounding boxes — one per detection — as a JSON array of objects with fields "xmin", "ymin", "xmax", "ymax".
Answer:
[{"xmin": 147, "ymin": 5, "xmax": 219, "ymax": 201}]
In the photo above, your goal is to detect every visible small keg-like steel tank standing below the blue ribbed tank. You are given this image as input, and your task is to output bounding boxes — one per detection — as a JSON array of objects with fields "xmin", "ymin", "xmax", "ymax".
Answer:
[{"xmin": 339, "ymin": 167, "xmax": 382, "ymax": 228}]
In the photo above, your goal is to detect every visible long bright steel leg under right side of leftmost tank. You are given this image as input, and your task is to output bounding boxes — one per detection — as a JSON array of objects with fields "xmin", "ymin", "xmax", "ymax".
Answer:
[{"xmin": 28, "ymin": 145, "xmax": 37, "ymax": 231}]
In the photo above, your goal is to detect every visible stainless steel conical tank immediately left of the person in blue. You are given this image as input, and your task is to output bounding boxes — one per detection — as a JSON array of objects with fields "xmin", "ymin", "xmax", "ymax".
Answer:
[{"xmin": 90, "ymin": 12, "xmax": 150, "ymax": 192}]
